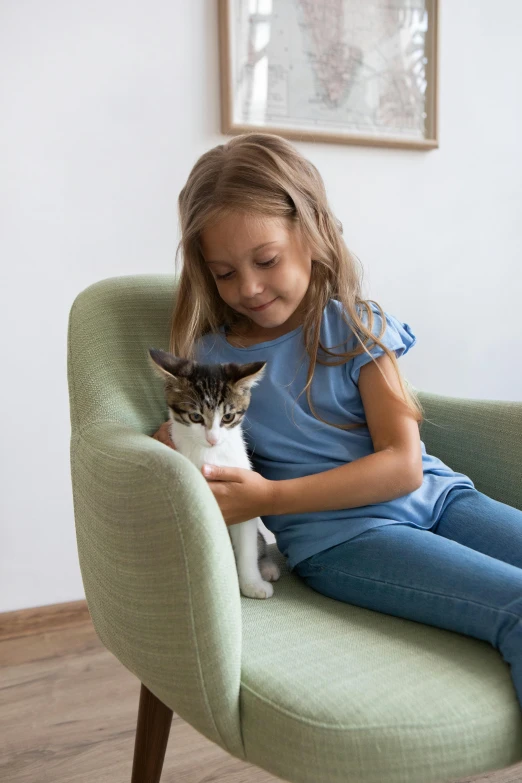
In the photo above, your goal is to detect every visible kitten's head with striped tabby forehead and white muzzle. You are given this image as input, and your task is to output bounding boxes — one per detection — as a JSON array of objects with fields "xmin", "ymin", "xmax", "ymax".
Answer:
[{"xmin": 149, "ymin": 348, "xmax": 266, "ymax": 447}]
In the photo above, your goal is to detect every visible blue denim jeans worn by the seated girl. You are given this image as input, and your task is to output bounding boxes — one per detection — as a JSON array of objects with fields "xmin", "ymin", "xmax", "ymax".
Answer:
[{"xmin": 294, "ymin": 488, "xmax": 522, "ymax": 709}]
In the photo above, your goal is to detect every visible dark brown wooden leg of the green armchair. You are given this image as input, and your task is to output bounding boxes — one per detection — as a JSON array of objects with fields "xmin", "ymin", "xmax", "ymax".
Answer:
[{"xmin": 131, "ymin": 683, "xmax": 172, "ymax": 783}]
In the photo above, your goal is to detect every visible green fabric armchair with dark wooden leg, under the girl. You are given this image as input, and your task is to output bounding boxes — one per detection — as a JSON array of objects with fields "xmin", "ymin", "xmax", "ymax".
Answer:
[{"xmin": 68, "ymin": 275, "xmax": 522, "ymax": 783}]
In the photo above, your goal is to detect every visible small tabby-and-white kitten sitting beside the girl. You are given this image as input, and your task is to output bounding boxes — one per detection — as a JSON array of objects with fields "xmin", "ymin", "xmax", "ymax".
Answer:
[{"xmin": 149, "ymin": 348, "xmax": 280, "ymax": 598}]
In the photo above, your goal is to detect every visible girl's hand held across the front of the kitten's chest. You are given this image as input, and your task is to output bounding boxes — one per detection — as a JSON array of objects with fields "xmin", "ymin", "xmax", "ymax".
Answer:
[{"xmin": 201, "ymin": 465, "xmax": 274, "ymax": 525}]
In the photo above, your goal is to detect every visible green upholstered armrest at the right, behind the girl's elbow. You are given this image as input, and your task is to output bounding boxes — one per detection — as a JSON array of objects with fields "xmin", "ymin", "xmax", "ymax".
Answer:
[{"xmin": 415, "ymin": 390, "xmax": 522, "ymax": 509}]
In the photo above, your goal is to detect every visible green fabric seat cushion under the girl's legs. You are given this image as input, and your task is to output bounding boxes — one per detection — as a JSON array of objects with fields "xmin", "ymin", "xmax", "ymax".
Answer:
[{"xmin": 241, "ymin": 544, "xmax": 522, "ymax": 783}]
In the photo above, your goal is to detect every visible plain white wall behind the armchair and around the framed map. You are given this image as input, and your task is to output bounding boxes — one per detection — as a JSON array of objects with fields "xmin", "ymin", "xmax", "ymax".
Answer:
[{"xmin": 0, "ymin": 0, "xmax": 522, "ymax": 611}]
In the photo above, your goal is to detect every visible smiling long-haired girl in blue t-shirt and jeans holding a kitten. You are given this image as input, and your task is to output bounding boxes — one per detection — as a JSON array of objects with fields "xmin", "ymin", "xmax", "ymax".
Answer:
[{"xmin": 153, "ymin": 133, "xmax": 522, "ymax": 707}]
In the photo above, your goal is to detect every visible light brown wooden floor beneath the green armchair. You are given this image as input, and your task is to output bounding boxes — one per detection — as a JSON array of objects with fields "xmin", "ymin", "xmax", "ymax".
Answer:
[{"xmin": 0, "ymin": 604, "xmax": 522, "ymax": 783}]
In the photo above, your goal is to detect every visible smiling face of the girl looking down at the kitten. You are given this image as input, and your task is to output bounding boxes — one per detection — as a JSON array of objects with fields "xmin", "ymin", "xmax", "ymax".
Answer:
[{"xmin": 201, "ymin": 213, "xmax": 312, "ymax": 335}]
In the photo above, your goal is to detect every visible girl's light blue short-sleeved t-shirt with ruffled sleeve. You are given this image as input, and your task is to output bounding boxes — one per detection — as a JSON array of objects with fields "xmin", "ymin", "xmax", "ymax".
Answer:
[{"xmin": 195, "ymin": 299, "xmax": 474, "ymax": 569}]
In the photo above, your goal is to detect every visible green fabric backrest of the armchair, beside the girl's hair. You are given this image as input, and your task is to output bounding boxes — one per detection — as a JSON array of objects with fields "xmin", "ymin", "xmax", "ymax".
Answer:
[{"xmin": 68, "ymin": 275, "xmax": 176, "ymax": 434}]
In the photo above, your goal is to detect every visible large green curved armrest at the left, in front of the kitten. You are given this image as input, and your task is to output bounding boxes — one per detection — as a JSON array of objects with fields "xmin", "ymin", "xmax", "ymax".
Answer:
[{"xmin": 71, "ymin": 421, "xmax": 245, "ymax": 758}]
